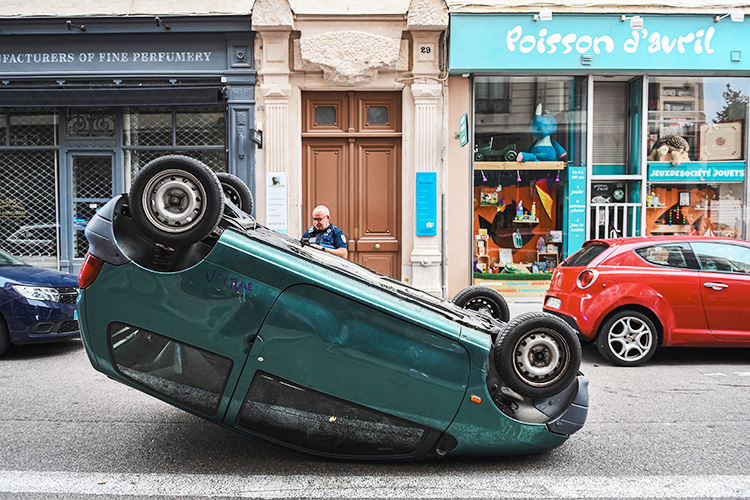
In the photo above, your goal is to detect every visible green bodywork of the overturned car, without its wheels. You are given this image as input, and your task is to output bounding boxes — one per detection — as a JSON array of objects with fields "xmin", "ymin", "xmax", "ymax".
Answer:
[{"xmin": 78, "ymin": 193, "xmax": 587, "ymax": 458}]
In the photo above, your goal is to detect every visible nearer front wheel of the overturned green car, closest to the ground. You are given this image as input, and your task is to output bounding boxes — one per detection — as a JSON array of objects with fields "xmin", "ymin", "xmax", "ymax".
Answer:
[{"xmin": 495, "ymin": 312, "xmax": 581, "ymax": 398}]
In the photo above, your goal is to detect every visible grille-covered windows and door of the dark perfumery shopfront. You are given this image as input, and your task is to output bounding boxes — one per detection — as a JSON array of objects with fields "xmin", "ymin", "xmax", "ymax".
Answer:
[{"xmin": 0, "ymin": 105, "xmax": 227, "ymax": 271}]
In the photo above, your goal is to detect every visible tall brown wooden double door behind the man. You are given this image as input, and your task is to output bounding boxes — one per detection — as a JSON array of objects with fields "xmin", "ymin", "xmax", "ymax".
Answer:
[{"xmin": 302, "ymin": 92, "xmax": 401, "ymax": 279}]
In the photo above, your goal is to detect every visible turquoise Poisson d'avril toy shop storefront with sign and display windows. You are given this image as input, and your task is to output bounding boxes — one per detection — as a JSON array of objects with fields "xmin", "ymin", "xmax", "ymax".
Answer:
[{"xmin": 449, "ymin": 13, "xmax": 750, "ymax": 294}]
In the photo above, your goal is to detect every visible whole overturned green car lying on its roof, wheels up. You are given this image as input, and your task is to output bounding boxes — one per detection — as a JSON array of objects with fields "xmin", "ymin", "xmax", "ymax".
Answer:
[{"xmin": 78, "ymin": 156, "xmax": 588, "ymax": 459}]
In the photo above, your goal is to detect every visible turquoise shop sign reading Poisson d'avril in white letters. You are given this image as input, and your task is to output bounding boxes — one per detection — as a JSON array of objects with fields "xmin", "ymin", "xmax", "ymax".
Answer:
[{"xmin": 449, "ymin": 13, "xmax": 750, "ymax": 74}]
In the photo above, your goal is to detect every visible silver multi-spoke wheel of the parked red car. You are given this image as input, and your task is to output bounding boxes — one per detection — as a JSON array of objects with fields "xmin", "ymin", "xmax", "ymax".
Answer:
[{"xmin": 596, "ymin": 310, "xmax": 657, "ymax": 366}]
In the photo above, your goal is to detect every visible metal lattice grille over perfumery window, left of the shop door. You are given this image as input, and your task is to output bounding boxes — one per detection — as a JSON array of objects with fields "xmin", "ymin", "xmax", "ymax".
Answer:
[{"xmin": 0, "ymin": 109, "xmax": 59, "ymax": 268}]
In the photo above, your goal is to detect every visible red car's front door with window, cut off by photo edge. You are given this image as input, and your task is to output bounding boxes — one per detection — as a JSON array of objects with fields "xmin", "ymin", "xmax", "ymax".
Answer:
[{"xmin": 690, "ymin": 241, "xmax": 750, "ymax": 343}]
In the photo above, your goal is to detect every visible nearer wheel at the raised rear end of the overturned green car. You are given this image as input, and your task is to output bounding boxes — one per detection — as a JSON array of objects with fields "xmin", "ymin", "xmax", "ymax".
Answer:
[{"xmin": 130, "ymin": 155, "xmax": 224, "ymax": 246}]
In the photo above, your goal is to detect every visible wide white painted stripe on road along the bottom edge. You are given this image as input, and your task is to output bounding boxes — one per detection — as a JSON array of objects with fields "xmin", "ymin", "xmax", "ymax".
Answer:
[{"xmin": 0, "ymin": 471, "xmax": 750, "ymax": 499}]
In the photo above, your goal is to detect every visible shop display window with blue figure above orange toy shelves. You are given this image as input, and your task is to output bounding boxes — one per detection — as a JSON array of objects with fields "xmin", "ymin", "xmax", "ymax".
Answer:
[{"xmin": 473, "ymin": 76, "xmax": 586, "ymax": 279}]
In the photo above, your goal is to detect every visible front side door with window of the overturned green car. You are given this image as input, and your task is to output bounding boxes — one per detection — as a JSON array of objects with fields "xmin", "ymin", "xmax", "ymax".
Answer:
[{"xmin": 225, "ymin": 284, "xmax": 469, "ymax": 456}]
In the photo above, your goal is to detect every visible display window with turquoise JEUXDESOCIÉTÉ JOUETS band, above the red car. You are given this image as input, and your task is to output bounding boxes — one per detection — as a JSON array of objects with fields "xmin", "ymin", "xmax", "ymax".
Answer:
[{"xmin": 646, "ymin": 77, "xmax": 750, "ymax": 238}]
